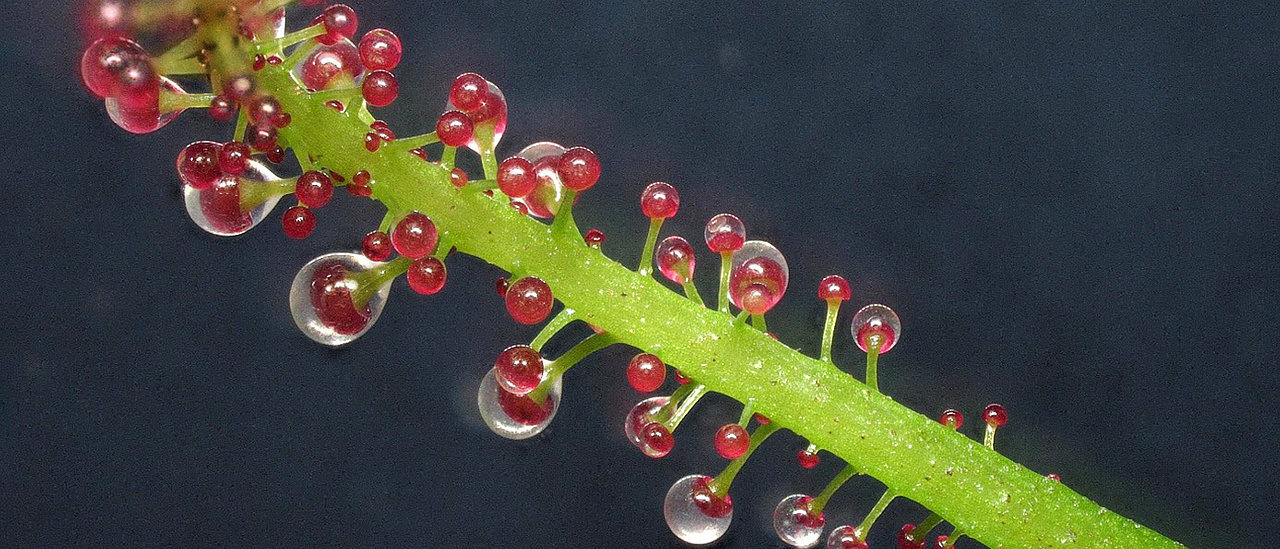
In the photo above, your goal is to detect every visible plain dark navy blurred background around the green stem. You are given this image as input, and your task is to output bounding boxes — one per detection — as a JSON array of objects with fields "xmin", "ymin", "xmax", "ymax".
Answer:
[{"xmin": 0, "ymin": 0, "xmax": 1280, "ymax": 548}]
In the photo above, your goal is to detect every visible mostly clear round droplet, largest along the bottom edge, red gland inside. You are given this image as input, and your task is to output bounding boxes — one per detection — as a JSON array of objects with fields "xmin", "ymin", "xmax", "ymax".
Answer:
[{"xmin": 662, "ymin": 475, "xmax": 733, "ymax": 545}]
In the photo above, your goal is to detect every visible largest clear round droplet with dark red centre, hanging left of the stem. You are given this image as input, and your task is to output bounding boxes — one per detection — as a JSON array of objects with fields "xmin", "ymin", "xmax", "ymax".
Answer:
[{"xmin": 289, "ymin": 252, "xmax": 394, "ymax": 347}]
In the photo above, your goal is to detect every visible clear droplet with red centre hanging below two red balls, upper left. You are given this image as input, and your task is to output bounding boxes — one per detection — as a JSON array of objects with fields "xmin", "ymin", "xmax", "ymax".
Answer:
[{"xmin": 182, "ymin": 160, "xmax": 284, "ymax": 237}]
